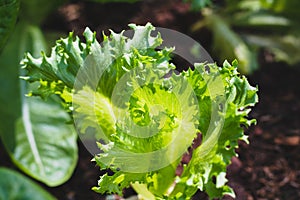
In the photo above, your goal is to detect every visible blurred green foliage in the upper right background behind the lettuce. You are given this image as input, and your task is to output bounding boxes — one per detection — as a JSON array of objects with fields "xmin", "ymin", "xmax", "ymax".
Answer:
[{"xmin": 192, "ymin": 0, "xmax": 300, "ymax": 74}]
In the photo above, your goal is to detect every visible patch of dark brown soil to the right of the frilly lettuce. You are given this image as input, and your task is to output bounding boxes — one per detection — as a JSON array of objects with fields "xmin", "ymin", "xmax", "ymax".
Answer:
[{"xmin": 228, "ymin": 63, "xmax": 300, "ymax": 200}]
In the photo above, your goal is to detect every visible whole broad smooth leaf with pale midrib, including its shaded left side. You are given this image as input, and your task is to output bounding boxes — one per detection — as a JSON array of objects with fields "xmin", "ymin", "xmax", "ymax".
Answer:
[{"xmin": 0, "ymin": 24, "xmax": 77, "ymax": 186}]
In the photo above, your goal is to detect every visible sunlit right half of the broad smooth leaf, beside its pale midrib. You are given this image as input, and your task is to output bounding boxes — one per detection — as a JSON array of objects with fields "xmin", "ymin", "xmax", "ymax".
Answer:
[{"xmin": 12, "ymin": 97, "xmax": 77, "ymax": 186}]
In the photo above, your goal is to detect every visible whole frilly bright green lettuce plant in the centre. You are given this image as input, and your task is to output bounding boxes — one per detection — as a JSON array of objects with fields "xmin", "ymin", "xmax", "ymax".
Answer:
[{"xmin": 22, "ymin": 23, "xmax": 258, "ymax": 199}]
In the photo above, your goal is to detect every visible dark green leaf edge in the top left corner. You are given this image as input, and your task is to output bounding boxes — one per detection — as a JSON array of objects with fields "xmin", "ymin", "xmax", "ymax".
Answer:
[{"xmin": 0, "ymin": 0, "xmax": 19, "ymax": 53}]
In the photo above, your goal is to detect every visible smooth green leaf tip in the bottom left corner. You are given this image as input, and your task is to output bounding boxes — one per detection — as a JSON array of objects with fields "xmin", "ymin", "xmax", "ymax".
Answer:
[{"xmin": 0, "ymin": 167, "xmax": 55, "ymax": 200}]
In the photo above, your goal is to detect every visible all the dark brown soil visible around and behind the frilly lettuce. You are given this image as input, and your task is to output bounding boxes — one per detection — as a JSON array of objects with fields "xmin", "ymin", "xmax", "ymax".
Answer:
[{"xmin": 0, "ymin": 0, "xmax": 300, "ymax": 200}]
